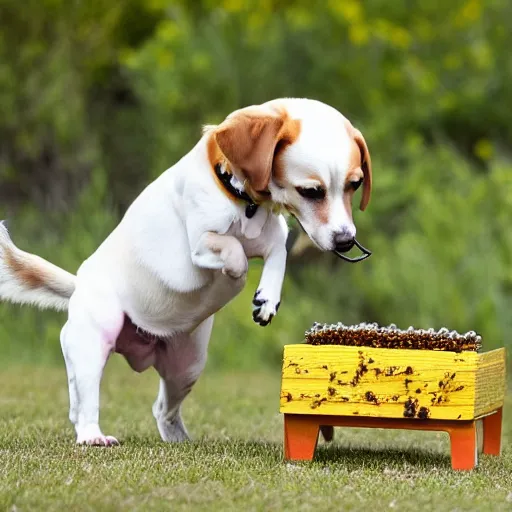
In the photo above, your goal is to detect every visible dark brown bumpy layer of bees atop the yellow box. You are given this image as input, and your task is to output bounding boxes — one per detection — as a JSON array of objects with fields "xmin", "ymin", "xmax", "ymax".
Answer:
[{"xmin": 305, "ymin": 322, "xmax": 482, "ymax": 352}]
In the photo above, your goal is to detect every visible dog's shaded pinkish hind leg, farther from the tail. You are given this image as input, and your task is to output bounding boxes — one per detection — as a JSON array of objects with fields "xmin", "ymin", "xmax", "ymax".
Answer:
[{"xmin": 153, "ymin": 315, "xmax": 213, "ymax": 442}]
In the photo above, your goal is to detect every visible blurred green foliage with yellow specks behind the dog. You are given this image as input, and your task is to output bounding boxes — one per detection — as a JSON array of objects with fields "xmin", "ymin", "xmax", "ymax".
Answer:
[{"xmin": 0, "ymin": 0, "xmax": 512, "ymax": 367}]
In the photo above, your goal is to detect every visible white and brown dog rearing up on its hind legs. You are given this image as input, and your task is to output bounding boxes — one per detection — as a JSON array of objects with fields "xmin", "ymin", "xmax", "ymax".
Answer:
[{"xmin": 0, "ymin": 98, "xmax": 372, "ymax": 446}]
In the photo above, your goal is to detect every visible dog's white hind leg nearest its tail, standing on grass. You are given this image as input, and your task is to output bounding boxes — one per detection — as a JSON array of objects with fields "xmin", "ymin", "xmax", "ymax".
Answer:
[{"xmin": 61, "ymin": 288, "xmax": 124, "ymax": 446}]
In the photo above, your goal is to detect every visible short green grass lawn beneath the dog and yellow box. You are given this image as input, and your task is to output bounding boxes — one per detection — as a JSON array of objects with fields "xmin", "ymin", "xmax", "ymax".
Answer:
[{"xmin": 0, "ymin": 360, "xmax": 512, "ymax": 511}]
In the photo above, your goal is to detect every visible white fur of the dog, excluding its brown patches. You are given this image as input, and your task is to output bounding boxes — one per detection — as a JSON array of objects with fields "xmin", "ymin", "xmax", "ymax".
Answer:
[{"xmin": 0, "ymin": 99, "xmax": 364, "ymax": 446}]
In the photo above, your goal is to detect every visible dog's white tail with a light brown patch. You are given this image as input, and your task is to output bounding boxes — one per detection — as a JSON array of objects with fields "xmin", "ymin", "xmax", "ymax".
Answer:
[{"xmin": 0, "ymin": 221, "xmax": 76, "ymax": 311}]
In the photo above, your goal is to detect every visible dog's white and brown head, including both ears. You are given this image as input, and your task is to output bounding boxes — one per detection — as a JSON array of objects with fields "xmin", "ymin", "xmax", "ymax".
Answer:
[{"xmin": 212, "ymin": 99, "xmax": 372, "ymax": 252}]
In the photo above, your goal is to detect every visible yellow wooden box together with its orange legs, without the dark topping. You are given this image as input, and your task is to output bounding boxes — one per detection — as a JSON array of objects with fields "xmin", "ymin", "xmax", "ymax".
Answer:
[{"xmin": 280, "ymin": 344, "xmax": 506, "ymax": 469}]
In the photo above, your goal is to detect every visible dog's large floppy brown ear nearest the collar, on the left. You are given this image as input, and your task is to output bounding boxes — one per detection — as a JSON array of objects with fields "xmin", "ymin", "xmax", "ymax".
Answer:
[{"xmin": 215, "ymin": 107, "xmax": 286, "ymax": 192}]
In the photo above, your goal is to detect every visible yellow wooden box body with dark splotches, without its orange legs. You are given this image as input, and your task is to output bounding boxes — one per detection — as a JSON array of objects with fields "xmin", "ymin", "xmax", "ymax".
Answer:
[{"xmin": 280, "ymin": 344, "xmax": 505, "ymax": 420}]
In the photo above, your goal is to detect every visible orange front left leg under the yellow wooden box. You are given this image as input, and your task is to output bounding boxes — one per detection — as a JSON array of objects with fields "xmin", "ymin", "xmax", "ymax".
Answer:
[{"xmin": 284, "ymin": 414, "xmax": 320, "ymax": 460}]
